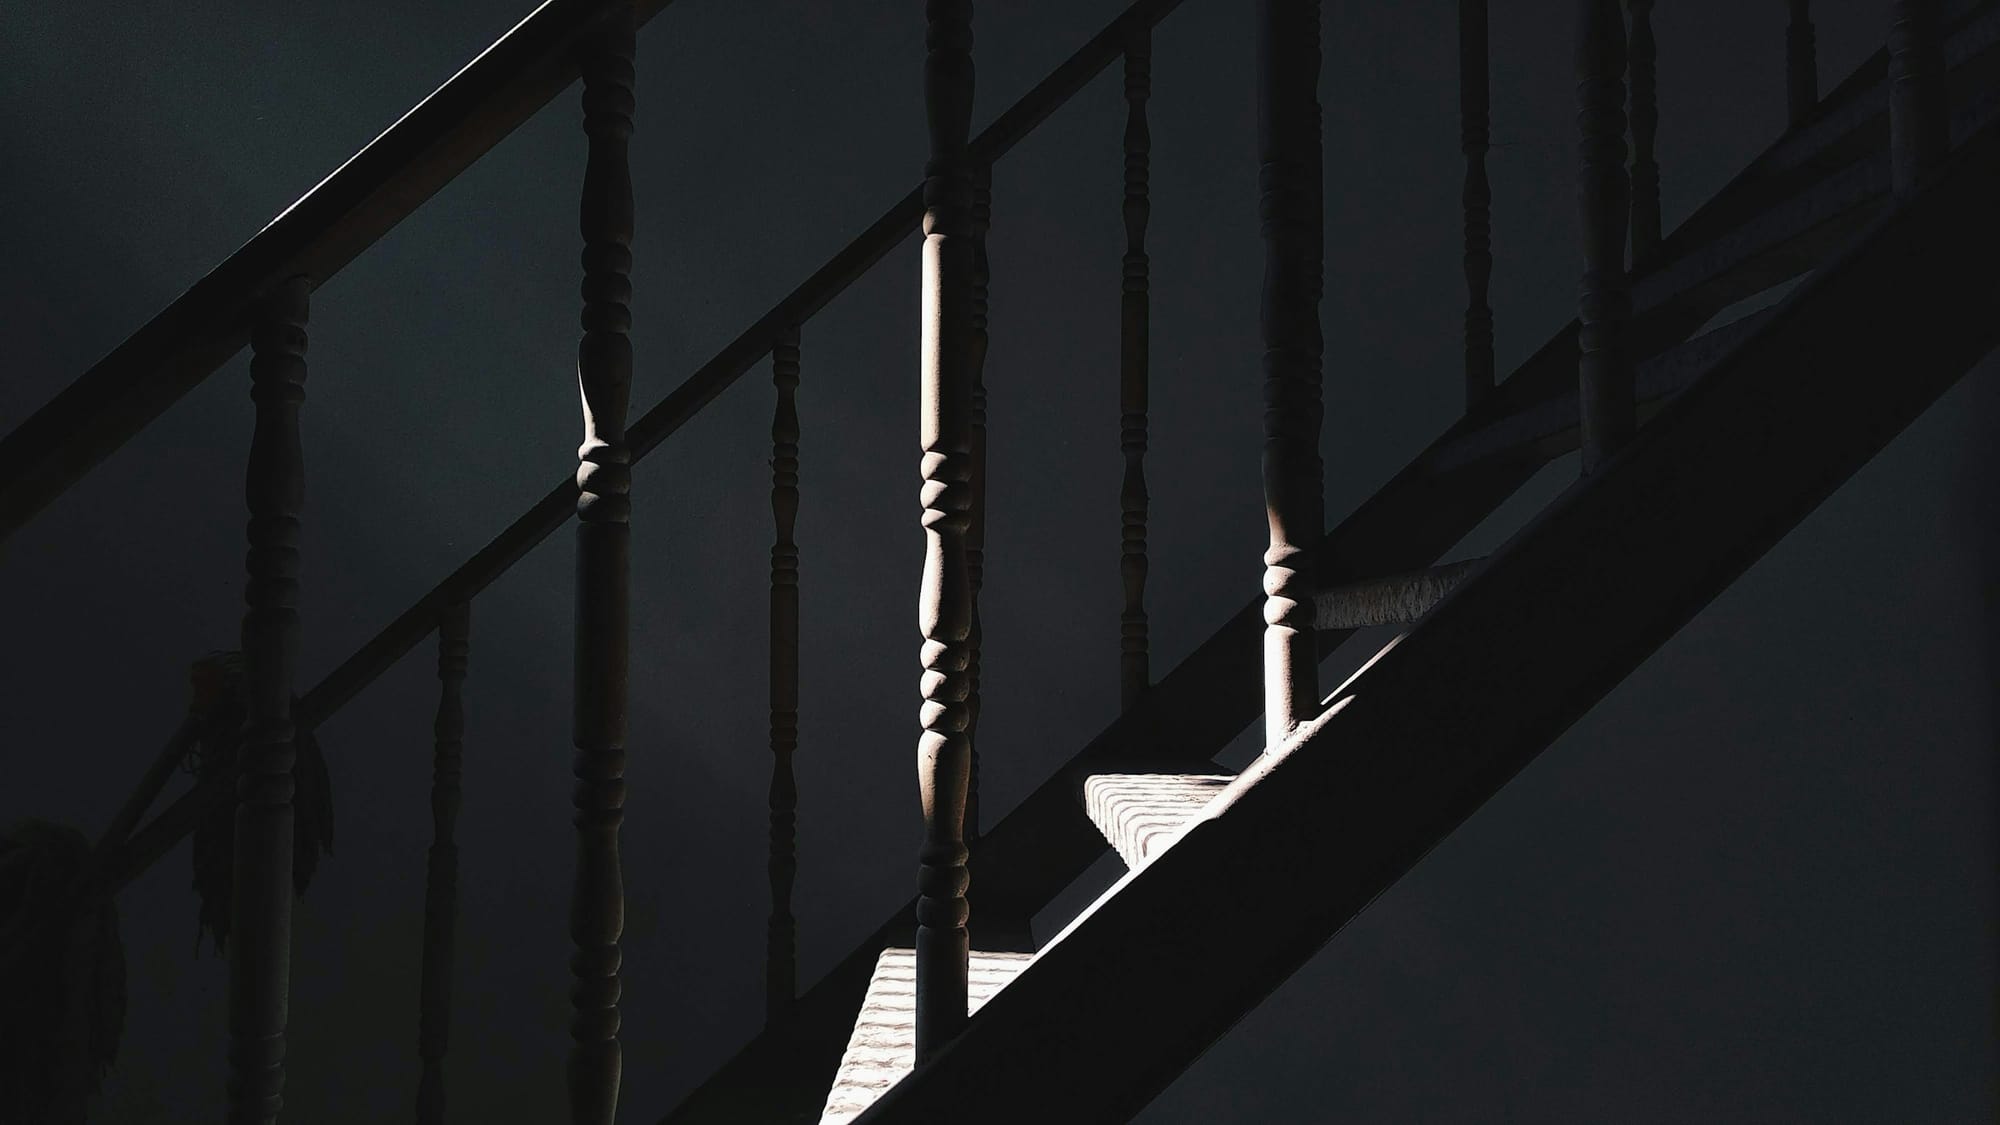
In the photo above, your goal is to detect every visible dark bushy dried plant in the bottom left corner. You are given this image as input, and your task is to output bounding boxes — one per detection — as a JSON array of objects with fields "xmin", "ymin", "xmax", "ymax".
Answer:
[{"xmin": 0, "ymin": 821, "xmax": 126, "ymax": 1121}]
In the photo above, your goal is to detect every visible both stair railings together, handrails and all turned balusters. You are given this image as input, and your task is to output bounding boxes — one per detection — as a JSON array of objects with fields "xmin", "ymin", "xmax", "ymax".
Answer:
[{"xmin": 0, "ymin": 0, "xmax": 1946, "ymax": 1121}]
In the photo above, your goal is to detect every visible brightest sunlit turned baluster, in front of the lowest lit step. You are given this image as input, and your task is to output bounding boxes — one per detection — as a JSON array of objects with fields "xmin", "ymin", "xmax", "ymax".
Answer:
[{"xmin": 916, "ymin": 0, "xmax": 978, "ymax": 1063}]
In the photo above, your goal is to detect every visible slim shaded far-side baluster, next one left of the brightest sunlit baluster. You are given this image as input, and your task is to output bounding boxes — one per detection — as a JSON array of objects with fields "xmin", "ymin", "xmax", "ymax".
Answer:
[{"xmin": 764, "ymin": 326, "xmax": 798, "ymax": 1023}]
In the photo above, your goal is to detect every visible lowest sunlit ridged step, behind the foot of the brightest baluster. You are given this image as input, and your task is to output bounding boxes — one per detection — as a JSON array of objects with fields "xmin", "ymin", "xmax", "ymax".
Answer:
[{"xmin": 820, "ymin": 949, "xmax": 1034, "ymax": 1125}]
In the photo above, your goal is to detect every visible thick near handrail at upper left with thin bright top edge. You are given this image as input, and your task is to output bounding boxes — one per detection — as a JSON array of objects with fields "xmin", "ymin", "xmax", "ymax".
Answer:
[{"xmin": 0, "ymin": 0, "xmax": 672, "ymax": 542}]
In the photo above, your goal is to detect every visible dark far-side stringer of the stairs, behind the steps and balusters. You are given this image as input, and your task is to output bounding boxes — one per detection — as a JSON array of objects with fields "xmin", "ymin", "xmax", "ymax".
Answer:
[{"xmin": 668, "ymin": 4, "xmax": 2000, "ymax": 1104}]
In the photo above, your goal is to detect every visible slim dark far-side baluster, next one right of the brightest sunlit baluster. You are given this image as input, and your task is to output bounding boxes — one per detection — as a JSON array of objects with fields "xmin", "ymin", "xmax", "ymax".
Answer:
[{"xmin": 1118, "ymin": 24, "xmax": 1152, "ymax": 711}]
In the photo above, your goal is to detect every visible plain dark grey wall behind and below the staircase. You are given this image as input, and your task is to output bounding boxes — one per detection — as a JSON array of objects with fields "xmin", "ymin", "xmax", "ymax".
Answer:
[{"xmin": 0, "ymin": 0, "xmax": 2000, "ymax": 1125}]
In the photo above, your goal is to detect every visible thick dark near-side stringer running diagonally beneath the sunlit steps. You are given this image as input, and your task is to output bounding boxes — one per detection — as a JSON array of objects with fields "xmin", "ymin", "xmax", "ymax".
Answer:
[{"xmin": 858, "ymin": 111, "xmax": 2000, "ymax": 1125}]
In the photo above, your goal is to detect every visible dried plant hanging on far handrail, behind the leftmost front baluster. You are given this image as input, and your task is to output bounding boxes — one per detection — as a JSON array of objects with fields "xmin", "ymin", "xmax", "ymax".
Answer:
[{"xmin": 190, "ymin": 653, "xmax": 334, "ymax": 953}]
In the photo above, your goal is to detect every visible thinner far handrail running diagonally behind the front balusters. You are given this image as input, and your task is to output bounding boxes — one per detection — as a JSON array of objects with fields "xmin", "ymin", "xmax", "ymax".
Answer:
[{"xmin": 94, "ymin": 0, "xmax": 1180, "ymax": 887}]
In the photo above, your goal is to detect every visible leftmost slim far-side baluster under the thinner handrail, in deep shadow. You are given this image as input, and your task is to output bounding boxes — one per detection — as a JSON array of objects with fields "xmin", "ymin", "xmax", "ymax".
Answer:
[{"xmin": 416, "ymin": 603, "xmax": 472, "ymax": 1125}]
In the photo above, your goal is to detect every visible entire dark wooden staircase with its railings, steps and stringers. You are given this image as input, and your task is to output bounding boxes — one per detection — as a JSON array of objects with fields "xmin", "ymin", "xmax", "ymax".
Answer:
[{"xmin": 0, "ymin": 0, "xmax": 2000, "ymax": 1125}]
